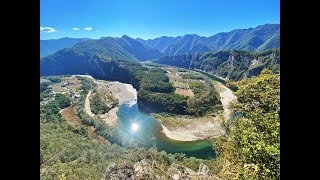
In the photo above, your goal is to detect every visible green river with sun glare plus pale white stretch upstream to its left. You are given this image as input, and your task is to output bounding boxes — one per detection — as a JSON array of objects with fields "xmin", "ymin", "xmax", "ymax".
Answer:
[{"xmin": 77, "ymin": 75, "xmax": 215, "ymax": 159}]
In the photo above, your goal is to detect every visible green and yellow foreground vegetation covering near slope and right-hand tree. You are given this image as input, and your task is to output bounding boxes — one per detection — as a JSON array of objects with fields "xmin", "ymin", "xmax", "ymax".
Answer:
[{"xmin": 40, "ymin": 70, "xmax": 280, "ymax": 179}]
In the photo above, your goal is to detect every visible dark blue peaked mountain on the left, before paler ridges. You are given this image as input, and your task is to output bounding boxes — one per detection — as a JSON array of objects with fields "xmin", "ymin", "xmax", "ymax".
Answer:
[{"xmin": 40, "ymin": 35, "xmax": 164, "ymax": 76}]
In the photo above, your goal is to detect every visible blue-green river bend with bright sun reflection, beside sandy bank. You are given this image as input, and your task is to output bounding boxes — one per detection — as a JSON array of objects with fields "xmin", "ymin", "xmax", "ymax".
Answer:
[{"xmin": 116, "ymin": 99, "xmax": 215, "ymax": 159}]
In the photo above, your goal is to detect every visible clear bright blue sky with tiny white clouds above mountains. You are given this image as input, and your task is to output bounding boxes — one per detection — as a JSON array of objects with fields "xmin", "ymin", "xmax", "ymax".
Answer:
[{"xmin": 40, "ymin": 0, "xmax": 280, "ymax": 39}]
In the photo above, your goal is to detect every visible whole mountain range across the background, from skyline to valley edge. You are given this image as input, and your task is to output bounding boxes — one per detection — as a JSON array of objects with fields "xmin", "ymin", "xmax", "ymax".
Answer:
[{"xmin": 40, "ymin": 24, "xmax": 280, "ymax": 80}]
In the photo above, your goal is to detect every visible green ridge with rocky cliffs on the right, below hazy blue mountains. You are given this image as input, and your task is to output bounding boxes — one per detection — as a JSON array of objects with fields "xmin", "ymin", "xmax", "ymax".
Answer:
[{"xmin": 153, "ymin": 49, "xmax": 280, "ymax": 80}]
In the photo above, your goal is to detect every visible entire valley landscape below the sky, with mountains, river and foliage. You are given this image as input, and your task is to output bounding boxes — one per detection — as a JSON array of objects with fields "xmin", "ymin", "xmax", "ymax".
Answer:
[{"xmin": 40, "ymin": 25, "xmax": 280, "ymax": 179}]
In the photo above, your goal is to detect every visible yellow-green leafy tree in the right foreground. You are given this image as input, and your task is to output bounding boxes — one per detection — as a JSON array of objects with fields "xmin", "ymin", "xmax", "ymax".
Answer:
[{"xmin": 217, "ymin": 70, "xmax": 280, "ymax": 179}]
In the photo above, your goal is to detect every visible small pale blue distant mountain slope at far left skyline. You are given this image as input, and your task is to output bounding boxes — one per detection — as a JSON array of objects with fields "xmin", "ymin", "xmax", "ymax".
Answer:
[{"xmin": 40, "ymin": 37, "xmax": 89, "ymax": 57}]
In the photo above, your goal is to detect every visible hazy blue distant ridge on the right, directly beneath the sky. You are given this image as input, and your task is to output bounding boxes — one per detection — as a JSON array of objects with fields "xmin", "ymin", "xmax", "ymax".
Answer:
[{"xmin": 136, "ymin": 24, "xmax": 280, "ymax": 55}]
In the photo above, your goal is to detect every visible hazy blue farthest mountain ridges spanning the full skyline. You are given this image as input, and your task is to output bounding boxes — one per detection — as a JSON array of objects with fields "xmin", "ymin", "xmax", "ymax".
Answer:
[{"xmin": 40, "ymin": 24, "xmax": 280, "ymax": 58}]
